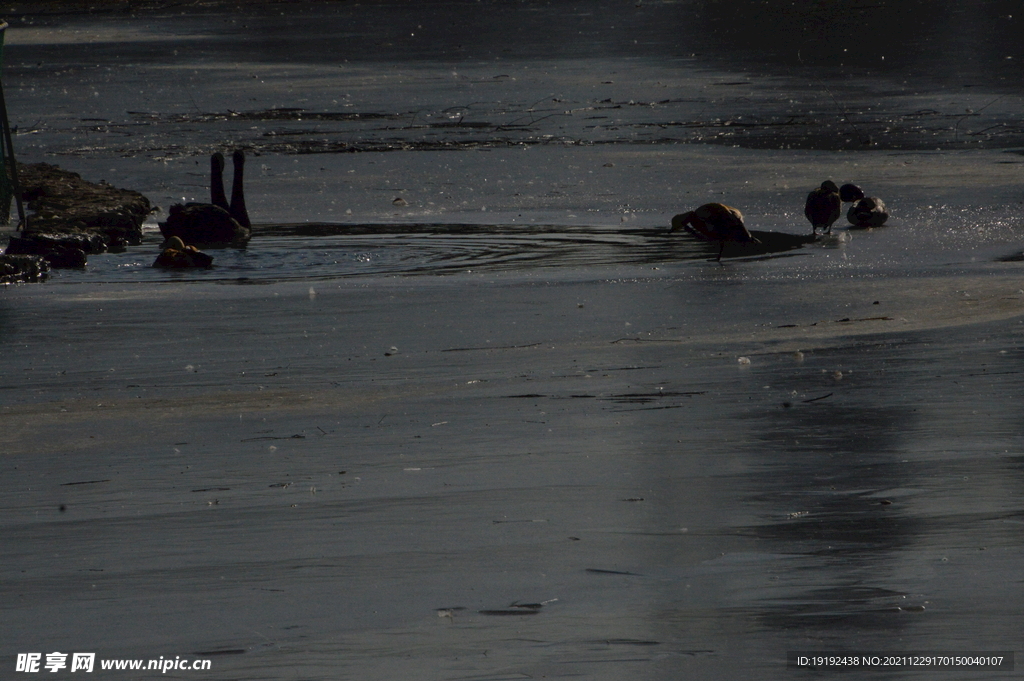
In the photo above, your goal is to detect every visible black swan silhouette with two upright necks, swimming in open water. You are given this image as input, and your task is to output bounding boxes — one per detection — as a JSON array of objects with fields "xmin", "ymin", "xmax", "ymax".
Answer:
[{"xmin": 160, "ymin": 151, "xmax": 252, "ymax": 246}]
